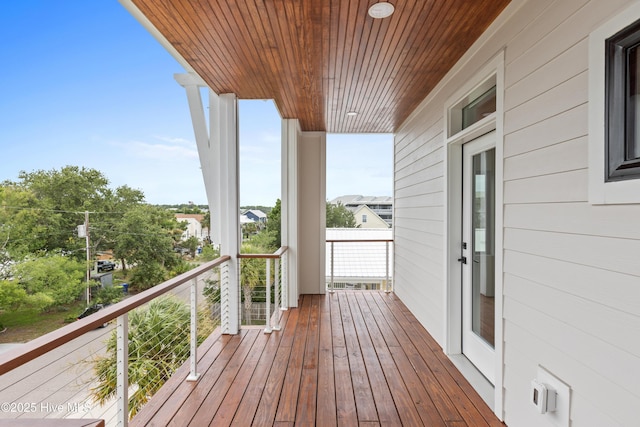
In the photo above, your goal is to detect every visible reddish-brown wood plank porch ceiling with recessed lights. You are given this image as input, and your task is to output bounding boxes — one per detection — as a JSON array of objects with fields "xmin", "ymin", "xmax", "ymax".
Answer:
[{"xmin": 132, "ymin": 0, "xmax": 509, "ymax": 133}]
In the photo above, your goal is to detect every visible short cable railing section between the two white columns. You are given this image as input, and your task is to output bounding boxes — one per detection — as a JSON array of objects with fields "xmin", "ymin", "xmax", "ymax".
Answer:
[{"xmin": 238, "ymin": 246, "xmax": 289, "ymax": 333}]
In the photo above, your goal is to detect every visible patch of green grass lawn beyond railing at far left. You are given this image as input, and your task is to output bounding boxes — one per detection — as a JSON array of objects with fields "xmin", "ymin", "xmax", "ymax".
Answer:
[{"xmin": 0, "ymin": 301, "xmax": 85, "ymax": 344}]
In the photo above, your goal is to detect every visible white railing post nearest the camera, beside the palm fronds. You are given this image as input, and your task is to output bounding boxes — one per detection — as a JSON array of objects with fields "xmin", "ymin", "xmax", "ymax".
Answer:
[{"xmin": 116, "ymin": 313, "xmax": 129, "ymax": 427}]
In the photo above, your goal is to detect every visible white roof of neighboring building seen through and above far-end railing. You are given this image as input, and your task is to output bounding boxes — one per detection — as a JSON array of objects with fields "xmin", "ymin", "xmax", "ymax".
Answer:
[{"xmin": 325, "ymin": 227, "xmax": 393, "ymax": 290}]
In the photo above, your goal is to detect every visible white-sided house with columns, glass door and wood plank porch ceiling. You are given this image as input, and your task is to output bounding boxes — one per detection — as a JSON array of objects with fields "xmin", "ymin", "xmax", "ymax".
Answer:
[{"xmin": 121, "ymin": 0, "xmax": 640, "ymax": 426}]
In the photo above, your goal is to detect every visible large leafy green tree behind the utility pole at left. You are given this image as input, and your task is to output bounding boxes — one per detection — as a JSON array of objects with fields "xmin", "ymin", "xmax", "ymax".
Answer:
[{"xmin": 0, "ymin": 166, "xmax": 144, "ymax": 260}]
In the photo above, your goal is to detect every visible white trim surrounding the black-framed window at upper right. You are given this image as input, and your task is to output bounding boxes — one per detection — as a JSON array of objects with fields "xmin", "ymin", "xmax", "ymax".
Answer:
[{"xmin": 589, "ymin": 3, "xmax": 640, "ymax": 205}]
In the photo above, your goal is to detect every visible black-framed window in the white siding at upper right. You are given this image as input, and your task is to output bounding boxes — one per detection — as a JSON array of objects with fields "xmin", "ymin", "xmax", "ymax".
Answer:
[{"xmin": 605, "ymin": 20, "xmax": 640, "ymax": 181}]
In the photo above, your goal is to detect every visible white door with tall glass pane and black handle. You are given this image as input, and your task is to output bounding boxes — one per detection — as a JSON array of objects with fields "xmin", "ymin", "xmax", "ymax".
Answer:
[{"xmin": 460, "ymin": 132, "xmax": 496, "ymax": 384}]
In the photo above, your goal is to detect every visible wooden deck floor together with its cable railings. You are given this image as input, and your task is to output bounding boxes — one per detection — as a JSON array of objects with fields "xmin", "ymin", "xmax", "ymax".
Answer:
[{"xmin": 0, "ymin": 246, "xmax": 502, "ymax": 426}]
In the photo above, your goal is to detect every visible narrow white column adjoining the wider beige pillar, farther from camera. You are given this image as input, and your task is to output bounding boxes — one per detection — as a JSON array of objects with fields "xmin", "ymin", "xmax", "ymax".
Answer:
[{"xmin": 280, "ymin": 119, "xmax": 301, "ymax": 307}]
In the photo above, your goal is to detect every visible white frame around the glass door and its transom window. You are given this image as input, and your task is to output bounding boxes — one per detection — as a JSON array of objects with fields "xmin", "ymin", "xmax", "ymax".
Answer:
[{"xmin": 443, "ymin": 50, "xmax": 504, "ymax": 420}]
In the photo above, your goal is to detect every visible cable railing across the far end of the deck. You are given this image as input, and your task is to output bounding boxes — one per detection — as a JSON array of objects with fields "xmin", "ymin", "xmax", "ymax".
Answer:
[{"xmin": 326, "ymin": 239, "xmax": 393, "ymax": 292}]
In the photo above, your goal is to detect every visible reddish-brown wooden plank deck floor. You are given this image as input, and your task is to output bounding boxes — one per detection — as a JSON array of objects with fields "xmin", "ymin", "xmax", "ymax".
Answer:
[{"xmin": 131, "ymin": 291, "xmax": 503, "ymax": 427}]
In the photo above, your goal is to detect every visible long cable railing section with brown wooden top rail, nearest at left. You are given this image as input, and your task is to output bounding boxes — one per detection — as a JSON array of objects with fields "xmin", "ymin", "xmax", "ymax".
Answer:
[{"xmin": 0, "ymin": 256, "xmax": 231, "ymax": 426}]
